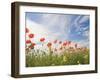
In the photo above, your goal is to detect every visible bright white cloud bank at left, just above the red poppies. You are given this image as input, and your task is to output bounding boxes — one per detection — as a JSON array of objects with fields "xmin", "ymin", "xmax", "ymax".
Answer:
[{"xmin": 26, "ymin": 19, "xmax": 67, "ymax": 43}]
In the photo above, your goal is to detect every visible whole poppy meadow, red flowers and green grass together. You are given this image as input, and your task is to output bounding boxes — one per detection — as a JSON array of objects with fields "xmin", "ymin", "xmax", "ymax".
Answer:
[{"xmin": 25, "ymin": 28, "xmax": 89, "ymax": 67}]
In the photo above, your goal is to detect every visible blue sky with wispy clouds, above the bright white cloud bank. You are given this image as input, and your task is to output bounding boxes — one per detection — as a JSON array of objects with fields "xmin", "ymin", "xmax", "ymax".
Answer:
[{"xmin": 26, "ymin": 12, "xmax": 90, "ymax": 47}]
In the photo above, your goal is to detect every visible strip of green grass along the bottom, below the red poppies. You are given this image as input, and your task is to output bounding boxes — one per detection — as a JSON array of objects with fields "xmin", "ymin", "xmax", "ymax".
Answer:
[{"xmin": 26, "ymin": 49, "xmax": 89, "ymax": 67}]
